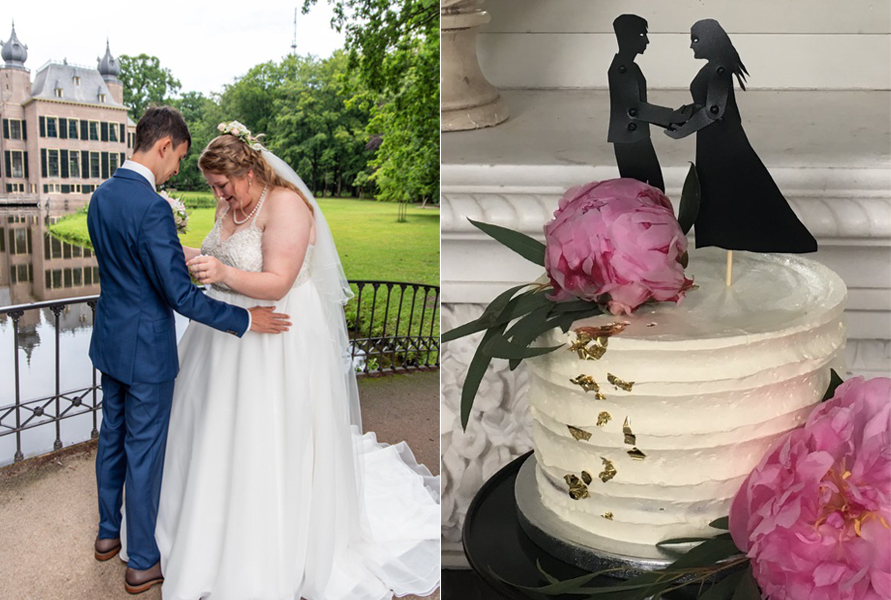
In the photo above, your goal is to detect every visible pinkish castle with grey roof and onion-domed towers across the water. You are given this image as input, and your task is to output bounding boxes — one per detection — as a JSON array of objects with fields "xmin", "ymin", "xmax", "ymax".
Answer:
[{"xmin": 0, "ymin": 25, "xmax": 136, "ymax": 204}]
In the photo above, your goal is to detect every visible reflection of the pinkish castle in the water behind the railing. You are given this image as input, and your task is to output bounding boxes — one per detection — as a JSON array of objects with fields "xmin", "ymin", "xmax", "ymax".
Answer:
[{"xmin": 0, "ymin": 208, "xmax": 99, "ymax": 347}]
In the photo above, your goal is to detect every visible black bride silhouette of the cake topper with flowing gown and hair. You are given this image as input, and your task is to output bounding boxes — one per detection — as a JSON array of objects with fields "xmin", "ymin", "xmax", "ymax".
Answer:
[{"xmin": 665, "ymin": 19, "xmax": 817, "ymax": 253}]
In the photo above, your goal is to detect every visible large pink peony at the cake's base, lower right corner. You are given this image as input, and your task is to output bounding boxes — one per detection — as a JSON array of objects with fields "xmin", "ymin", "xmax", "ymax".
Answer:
[{"xmin": 730, "ymin": 377, "xmax": 891, "ymax": 600}]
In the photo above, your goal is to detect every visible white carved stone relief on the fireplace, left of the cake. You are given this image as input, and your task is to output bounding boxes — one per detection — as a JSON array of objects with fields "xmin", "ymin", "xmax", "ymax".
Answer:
[{"xmin": 440, "ymin": 304, "xmax": 532, "ymax": 544}]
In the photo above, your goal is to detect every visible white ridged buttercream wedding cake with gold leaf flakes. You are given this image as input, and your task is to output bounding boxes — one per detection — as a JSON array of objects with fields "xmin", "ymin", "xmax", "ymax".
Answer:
[{"xmin": 526, "ymin": 248, "xmax": 847, "ymax": 550}]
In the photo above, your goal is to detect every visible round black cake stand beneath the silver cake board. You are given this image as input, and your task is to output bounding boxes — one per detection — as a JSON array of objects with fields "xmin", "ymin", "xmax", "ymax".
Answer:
[{"xmin": 463, "ymin": 452, "xmax": 695, "ymax": 600}]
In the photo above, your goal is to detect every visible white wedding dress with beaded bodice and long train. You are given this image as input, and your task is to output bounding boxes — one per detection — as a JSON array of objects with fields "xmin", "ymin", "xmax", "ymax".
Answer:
[{"xmin": 155, "ymin": 203, "xmax": 440, "ymax": 600}]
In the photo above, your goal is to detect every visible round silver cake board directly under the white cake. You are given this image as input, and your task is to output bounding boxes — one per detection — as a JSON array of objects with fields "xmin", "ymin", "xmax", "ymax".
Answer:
[{"xmin": 514, "ymin": 454, "xmax": 695, "ymax": 579}]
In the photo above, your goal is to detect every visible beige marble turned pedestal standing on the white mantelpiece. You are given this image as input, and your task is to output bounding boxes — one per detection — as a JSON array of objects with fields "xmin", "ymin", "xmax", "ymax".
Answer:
[{"xmin": 440, "ymin": 0, "xmax": 508, "ymax": 131}]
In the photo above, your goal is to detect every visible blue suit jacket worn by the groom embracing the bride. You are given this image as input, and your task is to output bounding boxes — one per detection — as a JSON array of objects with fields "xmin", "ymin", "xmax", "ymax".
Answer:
[{"xmin": 87, "ymin": 169, "xmax": 249, "ymax": 384}]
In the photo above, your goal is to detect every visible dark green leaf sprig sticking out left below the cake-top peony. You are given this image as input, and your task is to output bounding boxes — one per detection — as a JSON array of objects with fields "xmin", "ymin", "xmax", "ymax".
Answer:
[{"xmin": 442, "ymin": 219, "xmax": 605, "ymax": 429}]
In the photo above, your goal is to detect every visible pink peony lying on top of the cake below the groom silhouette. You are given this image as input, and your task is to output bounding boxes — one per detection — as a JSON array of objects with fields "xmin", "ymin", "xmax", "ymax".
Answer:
[{"xmin": 544, "ymin": 179, "xmax": 693, "ymax": 315}]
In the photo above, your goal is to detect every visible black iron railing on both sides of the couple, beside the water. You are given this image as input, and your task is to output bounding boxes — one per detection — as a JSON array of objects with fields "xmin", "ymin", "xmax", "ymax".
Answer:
[{"xmin": 0, "ymin": 281, "xmax": 439, "ymax": 464}]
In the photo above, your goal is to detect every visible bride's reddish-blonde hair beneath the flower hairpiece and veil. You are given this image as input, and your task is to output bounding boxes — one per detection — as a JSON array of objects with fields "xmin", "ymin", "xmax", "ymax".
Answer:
[{"xmin": 198, "ymin": 133, "xmax": 313, "ymax": 212}]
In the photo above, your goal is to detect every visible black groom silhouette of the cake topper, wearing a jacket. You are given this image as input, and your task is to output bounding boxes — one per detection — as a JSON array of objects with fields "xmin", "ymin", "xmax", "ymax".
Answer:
[{"xmin": 607, "ymin": 15, "xmax": 690, "ymax": 192}]
